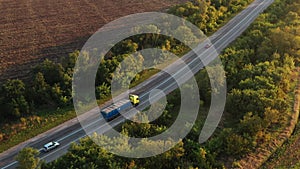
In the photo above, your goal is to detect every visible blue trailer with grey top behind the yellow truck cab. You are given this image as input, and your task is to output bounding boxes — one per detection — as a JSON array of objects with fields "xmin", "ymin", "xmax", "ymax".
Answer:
[{"xmin": 101, "ymin": 99, "xmax": 133, "ymax": 121}]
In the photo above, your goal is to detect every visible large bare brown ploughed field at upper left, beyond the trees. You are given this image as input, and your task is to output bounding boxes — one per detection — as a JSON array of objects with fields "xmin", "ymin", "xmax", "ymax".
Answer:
[{"xmin": 0, "ymin": 0, "xmax": 187, "ymax": 82}]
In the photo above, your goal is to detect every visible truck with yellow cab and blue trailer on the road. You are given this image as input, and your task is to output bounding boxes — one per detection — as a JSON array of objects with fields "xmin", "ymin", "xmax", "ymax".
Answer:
[{"xmin": 101, "ymin": 94, "xmax": 140, "ymax": 121}]
